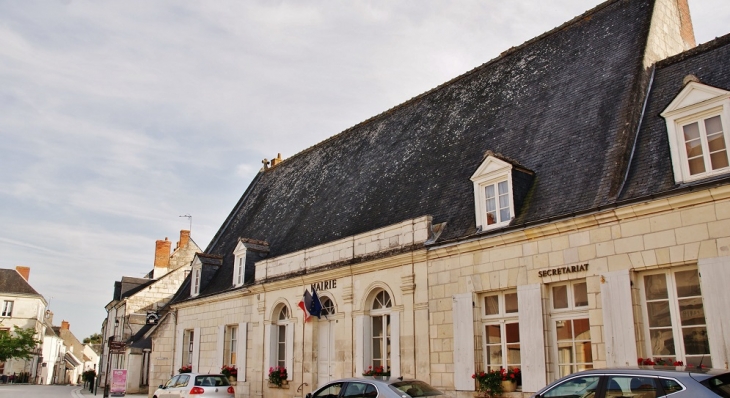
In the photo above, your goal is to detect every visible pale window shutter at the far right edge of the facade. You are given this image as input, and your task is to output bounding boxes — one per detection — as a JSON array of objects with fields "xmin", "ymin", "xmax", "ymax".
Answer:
[{"xmin": 699, "ymin": 257, "xmax": 730, "ymax": 368}]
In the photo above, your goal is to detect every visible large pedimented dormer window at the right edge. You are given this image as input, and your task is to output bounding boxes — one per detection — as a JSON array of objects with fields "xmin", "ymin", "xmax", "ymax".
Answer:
[{"xmin": 661, "ymin": 81, "xmax": 730, "ymax": 184}]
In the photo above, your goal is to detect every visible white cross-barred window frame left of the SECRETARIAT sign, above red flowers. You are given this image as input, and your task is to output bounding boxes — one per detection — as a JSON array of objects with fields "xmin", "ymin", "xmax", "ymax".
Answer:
[{"xmin": 479, "ymin": 290, "xmax": 522, "ymax": 371}]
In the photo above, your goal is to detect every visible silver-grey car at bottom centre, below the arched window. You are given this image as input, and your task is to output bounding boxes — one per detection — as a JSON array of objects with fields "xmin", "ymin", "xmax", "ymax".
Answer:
[{"xmin": 307, "ymin": 377, "xmax": 444, "ymax": 398}]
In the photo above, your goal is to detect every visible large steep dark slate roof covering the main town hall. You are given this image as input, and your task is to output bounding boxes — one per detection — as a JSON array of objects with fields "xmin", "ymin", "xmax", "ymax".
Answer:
[{"xmin": 181, "ymin": 0, "xmax": 654, "ymax": 299}]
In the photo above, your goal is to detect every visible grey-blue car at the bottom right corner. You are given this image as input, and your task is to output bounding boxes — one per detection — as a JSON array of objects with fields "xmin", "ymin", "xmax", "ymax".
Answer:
[{"xmin": 532, "ymin": 366, "xmax": 730, "ymax": 398}]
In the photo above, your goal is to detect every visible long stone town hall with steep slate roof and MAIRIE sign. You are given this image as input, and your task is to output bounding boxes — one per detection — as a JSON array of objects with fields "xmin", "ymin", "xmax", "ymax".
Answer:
[{"xmin": 151, "ymin": 0, "xmax": 730, "ymax": 398}]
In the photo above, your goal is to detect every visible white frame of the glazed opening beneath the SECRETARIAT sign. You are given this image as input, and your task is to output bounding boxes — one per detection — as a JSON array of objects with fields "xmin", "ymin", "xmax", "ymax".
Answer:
[{"xmin": 548, "ymin": 279, "xmax": 596, "ymax": 378}]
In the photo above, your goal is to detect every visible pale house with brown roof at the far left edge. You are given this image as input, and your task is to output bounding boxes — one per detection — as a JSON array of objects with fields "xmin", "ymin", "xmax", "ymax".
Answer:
[{"xmin": 0, "ymin": 266, "xmax": 48, "ymax": 380}]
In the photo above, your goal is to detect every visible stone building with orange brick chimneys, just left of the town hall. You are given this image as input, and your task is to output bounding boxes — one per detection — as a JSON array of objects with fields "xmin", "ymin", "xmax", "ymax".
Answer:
[{"xmin": 97, "ymin": 230, "xmax": 201, "ymax": 394}]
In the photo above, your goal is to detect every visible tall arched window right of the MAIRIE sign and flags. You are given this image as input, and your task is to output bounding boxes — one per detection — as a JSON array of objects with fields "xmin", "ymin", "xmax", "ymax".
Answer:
[{"xmin": 370, "ymin": 290, "xmax": 393, "ymax": 371}]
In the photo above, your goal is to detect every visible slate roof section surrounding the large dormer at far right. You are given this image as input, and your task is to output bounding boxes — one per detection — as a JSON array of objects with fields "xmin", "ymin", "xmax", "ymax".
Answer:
[{"xmin": 621, "ymin": 35, "xmax": 730, "ymax": 200}]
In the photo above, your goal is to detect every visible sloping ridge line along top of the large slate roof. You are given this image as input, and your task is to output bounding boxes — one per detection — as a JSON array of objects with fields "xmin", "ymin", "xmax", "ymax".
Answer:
[{"xmin": 262, "ymin": 0, "xmax": 624, "ymax": 173}]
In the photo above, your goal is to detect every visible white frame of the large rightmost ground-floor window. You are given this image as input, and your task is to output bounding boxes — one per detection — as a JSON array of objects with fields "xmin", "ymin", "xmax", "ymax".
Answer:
[{"xmin": 639, "ymin": 266, "xmax": 712, "ymax": 366}]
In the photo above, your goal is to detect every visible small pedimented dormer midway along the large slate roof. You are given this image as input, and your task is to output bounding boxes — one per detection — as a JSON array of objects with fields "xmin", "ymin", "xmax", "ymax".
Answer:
[{"xmin": 471, "ymin": 152, "xmax": 533, "ymax": 231}]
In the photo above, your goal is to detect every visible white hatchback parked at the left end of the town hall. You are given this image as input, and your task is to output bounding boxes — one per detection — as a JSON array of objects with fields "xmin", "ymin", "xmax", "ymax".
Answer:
[{"xmin": 152, "ymin": 373, "xmax": 235, "ymax": 398}]
